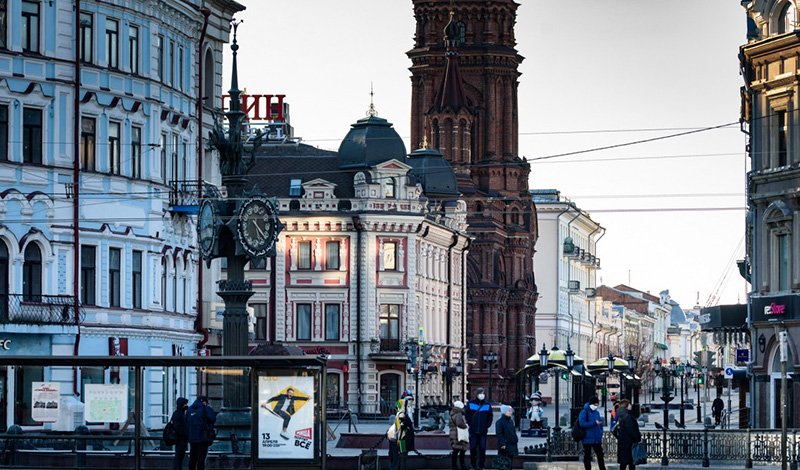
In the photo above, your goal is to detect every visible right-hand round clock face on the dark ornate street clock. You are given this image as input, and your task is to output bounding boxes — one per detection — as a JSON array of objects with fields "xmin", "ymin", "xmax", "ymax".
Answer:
[{"xmin": 238, "ymin": 197, "xmax": 277, "ymax": 256}]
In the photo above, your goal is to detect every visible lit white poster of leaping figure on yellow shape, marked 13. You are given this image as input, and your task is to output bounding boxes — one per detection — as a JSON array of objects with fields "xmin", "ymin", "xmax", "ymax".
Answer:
[{"xmin": 257, "ymin": 375, "xmax": 318, "ymax": 460}]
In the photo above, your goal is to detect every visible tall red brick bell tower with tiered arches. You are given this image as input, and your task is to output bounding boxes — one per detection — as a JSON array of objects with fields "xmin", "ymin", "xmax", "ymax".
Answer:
[{"xmin": 408, "ymin": 0, "xmax": 538, "ymax": 402}]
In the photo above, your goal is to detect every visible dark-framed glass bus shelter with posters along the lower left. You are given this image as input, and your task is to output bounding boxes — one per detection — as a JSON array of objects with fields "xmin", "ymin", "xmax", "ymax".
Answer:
[{"xmin": 0, "ymin": 356, "xmax": 327, "ymax": 470}]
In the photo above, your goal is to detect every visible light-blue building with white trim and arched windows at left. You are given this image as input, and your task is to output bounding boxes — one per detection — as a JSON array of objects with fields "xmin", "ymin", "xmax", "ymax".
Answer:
[{"xmin": 0, "ymin": 0, "xmax": 243, "ymax": 430}]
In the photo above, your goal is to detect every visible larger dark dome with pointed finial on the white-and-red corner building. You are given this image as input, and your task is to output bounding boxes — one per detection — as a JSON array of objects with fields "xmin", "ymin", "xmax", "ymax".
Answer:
[{"xmin": 339, "ymin": 113, "xmax": 406, "ymax": 170}]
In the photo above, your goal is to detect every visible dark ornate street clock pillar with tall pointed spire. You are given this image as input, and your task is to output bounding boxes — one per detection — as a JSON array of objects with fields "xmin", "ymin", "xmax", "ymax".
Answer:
[{"xmin": 197, "ymin": 21, "xmax": 281, "ymax": 444}]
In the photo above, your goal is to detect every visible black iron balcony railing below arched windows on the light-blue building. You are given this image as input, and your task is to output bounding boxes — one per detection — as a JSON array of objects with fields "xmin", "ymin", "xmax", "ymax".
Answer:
[{"xmin": 0, "ymin": 294, "xmax": 84, "ymax": 325}]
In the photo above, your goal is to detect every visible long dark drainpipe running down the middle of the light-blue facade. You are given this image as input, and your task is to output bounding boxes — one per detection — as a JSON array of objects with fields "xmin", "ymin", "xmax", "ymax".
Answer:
[{"xmin": 72, "ymin": 0, "xmax": 81, "ymax": 396}]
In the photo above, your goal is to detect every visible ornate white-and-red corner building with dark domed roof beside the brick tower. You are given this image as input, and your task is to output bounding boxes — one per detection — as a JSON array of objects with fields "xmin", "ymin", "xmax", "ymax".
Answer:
[{"xmin": 214, "ymin": 111, "xmax": 471, "ymax": 415}]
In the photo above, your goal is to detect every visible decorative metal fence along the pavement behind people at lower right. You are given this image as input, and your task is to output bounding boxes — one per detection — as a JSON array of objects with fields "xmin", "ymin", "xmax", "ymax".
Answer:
[{"xmin": 548, "ymin": 429, "xmax": 800, "ymax": 468}]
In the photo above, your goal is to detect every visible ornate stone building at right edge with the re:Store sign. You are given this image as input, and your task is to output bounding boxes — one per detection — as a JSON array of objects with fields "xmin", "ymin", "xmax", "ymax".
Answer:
[{"xmin": 739, "ymin": 0, "xmax": 800, "ymax": 428}]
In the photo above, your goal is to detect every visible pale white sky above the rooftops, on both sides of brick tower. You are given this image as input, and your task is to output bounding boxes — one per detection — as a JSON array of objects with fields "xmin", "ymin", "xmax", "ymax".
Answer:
[{"xmin": 223, "ymin": 0, "xmax": 749, "ymax": 308}]
